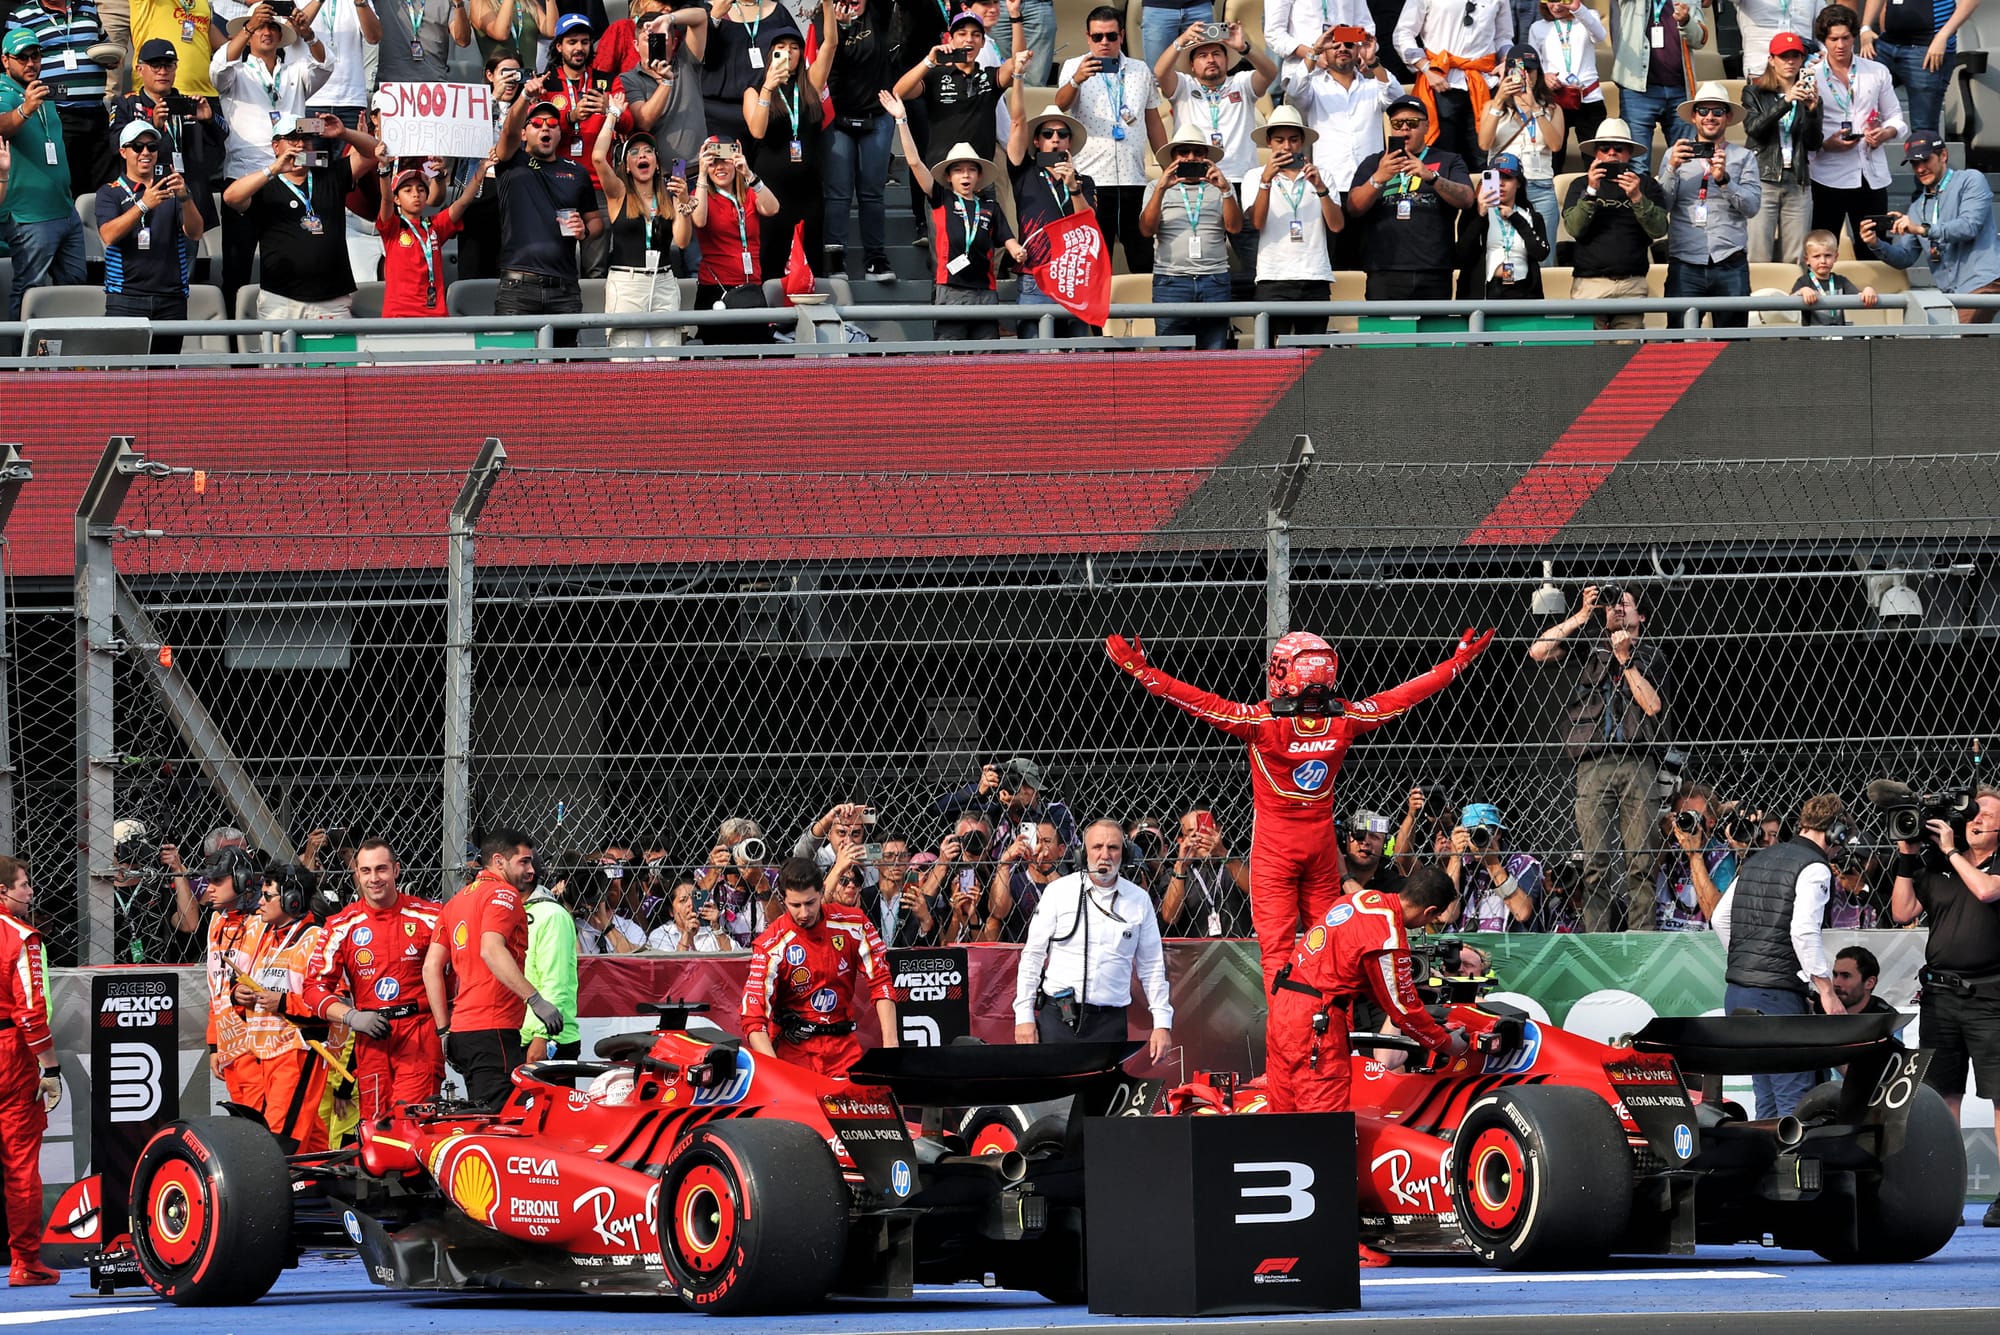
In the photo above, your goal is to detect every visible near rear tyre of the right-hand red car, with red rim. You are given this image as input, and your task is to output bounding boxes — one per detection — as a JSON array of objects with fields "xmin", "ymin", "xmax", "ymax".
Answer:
[{"xmin": 1446, "ymin": 1085, "xmax": 1632, "ymax": 1269}]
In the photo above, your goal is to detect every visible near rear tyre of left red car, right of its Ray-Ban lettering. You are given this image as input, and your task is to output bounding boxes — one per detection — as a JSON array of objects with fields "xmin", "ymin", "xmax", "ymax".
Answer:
[{"xmin": 654, "ymin": 1117, "xmax": 850, "ymax": 1315}]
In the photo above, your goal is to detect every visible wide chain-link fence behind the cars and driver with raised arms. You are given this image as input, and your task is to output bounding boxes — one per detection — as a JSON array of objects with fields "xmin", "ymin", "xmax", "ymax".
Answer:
[{"xmin": 8, "ymin": 445, "xmax": 2000, "ymax": 959}]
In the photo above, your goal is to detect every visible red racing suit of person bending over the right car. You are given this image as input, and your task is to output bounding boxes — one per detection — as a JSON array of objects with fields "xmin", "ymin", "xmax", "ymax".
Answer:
[{"xmin": 1264, "ymin": 889, "xmax": 1452, "ymax": 1113}]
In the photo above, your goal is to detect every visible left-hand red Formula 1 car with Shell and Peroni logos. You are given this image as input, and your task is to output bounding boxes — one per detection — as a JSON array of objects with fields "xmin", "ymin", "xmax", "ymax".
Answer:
[{"xmin": 132, "ymin": 1003, "xmax": 1136, "ymax": 1313}]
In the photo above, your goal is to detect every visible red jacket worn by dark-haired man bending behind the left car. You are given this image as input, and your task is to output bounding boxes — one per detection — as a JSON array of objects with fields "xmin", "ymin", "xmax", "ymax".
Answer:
[{"xmin": 742, "ymin": 903, "xmax": 892, "ymax": 1039}]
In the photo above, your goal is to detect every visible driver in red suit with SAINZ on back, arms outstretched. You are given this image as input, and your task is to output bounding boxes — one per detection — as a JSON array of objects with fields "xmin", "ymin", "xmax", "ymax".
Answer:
[{"xmin": 1104, "ymin": 630, "xmax": 1494, "ymax": 991}]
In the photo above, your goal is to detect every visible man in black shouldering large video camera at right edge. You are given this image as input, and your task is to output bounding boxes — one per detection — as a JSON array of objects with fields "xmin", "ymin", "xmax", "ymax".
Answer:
[{"xmin": 1868, "ymin": 779, "xmax": 2000, "ymax": 1229}]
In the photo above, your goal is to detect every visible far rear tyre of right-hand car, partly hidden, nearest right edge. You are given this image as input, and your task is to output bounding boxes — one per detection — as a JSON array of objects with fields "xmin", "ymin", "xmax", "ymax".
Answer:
[{"xmin": 1792, "ymin": 1081, "xmax": 1966, "ymax": 1265}]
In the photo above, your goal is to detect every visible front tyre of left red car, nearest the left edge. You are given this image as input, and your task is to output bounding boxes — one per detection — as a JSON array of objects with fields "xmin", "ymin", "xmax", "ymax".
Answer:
[{"xmin": 132, "ymin": 1117, "xmax": 292, "ymax": 1307}]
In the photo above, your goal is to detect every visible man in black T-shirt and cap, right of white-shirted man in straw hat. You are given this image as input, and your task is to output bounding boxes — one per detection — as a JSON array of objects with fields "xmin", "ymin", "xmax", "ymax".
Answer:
[{"xmin": 1346, "ymin": 93, "xmax": 1480, "ymax": 302}]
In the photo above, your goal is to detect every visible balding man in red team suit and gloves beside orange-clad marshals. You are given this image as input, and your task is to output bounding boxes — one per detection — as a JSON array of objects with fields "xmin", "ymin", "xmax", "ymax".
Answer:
[{"xmin": 306, "ymin": 839, "xmax": 444, "ymax": 1117}]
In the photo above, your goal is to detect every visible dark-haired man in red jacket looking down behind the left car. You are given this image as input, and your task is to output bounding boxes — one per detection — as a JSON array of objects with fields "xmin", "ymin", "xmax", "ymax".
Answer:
[{"xmin": 742, "ymin": 857, "xmax": 896, "ymax": 1079}]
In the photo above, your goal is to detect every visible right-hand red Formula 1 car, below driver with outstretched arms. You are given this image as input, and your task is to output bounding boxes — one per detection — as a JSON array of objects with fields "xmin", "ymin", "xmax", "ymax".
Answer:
[{"xmin": 1164, "ymin": 1003, "xmax": 1966, "ymax": 1269}]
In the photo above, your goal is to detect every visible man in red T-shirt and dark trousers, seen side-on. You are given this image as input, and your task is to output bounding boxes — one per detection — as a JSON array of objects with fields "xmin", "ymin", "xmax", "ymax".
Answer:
[{"xmin": 424, "ymin": 829, "xmax": 562, "ymax": 1107}]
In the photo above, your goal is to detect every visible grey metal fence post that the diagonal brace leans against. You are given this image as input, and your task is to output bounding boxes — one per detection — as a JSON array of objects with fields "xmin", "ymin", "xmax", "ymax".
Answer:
[{"xmin": 76, "ymin": 436, "xmax": 150, "ymax": 963}]
